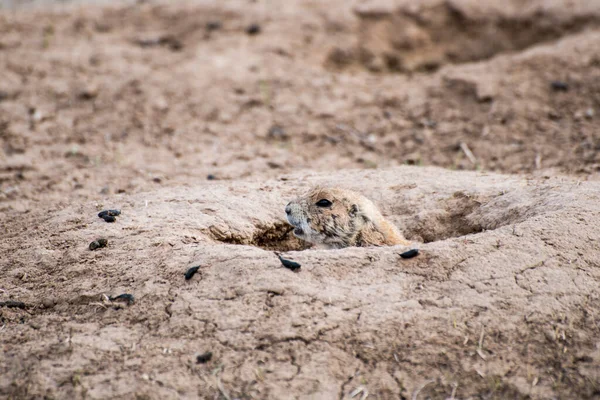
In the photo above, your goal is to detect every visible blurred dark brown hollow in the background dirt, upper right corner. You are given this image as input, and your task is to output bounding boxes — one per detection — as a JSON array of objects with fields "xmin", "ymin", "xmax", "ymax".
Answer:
[{"xmin": 326, "ymin": 1, "xmax": 600, "ymax": 73}]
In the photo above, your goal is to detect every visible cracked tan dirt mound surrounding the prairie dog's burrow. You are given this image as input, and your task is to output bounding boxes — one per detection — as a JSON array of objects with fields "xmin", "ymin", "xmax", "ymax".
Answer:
[{"xmin": 0, "ymin": 167, "xmax": 600, "ymax": 398}]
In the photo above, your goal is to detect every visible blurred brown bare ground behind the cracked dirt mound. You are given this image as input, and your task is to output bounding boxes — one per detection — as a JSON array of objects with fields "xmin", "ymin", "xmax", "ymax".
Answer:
[{"xmin": 0, "ymin": 0, "xmax": 600, "ymax": 212}]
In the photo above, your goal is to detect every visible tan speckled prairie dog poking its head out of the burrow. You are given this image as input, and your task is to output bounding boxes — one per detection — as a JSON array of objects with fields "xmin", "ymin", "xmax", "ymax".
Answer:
[{"xmin": 286, "ymin": 188, "xmax": 409, "ymax": 248}]
